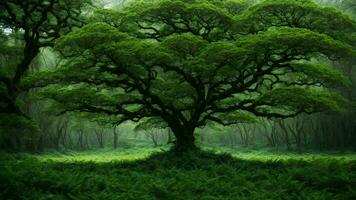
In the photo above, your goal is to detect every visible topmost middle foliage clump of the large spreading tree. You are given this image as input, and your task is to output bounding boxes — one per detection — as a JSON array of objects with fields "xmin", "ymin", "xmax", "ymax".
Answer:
[{"xmin": 125, "ymin": 0, "xmax": 239, "ymax": 41}]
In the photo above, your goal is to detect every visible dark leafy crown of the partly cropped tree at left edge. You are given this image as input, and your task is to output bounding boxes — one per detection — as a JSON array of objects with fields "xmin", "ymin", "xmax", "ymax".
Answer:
[{"xmin": 0, "ymin": 0, "xmax": 91, "ymax": 30}]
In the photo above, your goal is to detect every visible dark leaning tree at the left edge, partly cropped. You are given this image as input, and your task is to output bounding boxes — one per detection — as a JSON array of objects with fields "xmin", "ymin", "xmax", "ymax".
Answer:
[{"xmin": 0, "ymin": 0, "xmax": 89, "ymax": 114}]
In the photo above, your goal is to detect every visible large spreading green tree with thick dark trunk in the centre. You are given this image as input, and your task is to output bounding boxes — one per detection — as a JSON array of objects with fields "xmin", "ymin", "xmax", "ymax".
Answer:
[{"xmin": 29, "ymin": 0, "xmax": 356, "ymax": 151}]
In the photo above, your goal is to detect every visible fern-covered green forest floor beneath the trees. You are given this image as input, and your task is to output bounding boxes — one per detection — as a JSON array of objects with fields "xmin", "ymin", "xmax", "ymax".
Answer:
[{"xmin": 0, "ymin": 148, "xmax": 356, "ymax": 200}]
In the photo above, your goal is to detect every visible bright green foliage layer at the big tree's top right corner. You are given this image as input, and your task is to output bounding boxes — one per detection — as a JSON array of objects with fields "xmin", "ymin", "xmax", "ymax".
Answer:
[{"xmin": 242, "ymin": 0, "xmax": 356, "ymax": 45}]
